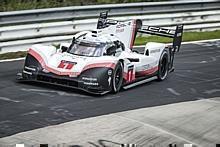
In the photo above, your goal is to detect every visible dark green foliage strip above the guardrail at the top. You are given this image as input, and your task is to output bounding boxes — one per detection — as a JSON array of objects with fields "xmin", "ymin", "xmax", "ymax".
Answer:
[{"xmin": 0, "ymin": 0, "xmax": 165, "ymax": 11}]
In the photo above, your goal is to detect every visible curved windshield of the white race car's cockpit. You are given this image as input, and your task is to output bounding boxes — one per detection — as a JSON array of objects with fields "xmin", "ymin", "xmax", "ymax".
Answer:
[{"xmin": 68, "ymin": 42, "xmax": 105, "ymax": 57}]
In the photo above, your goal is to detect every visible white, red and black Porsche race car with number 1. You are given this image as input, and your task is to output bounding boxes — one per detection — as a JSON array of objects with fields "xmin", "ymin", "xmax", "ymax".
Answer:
[{"xmin": 18, "ymin": 12, "xmax": 183, "ymax": 94}]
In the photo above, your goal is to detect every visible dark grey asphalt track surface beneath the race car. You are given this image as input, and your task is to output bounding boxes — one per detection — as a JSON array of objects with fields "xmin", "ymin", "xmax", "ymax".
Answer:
[{"xmin": 0, "ymin": 41, "xmax": 220, "ymax": 137}]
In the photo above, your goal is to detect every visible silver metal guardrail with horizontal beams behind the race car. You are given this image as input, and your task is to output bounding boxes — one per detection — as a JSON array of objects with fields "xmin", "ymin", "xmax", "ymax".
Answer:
[{"xmin": 0, "ymin": 0, "xmax": 220, "ymax": 53}]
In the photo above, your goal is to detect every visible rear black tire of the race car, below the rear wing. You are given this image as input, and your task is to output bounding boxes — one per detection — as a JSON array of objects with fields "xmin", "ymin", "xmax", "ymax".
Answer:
[{"xmin": 157, "ymin": 50, "xmax": 169, "ymax": 81}]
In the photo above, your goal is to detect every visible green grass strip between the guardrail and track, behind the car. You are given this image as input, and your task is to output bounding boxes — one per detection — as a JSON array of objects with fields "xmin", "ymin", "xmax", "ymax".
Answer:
[{"xmin": 0, "ymin": 30, "xmax": 220, "ymax": 60}]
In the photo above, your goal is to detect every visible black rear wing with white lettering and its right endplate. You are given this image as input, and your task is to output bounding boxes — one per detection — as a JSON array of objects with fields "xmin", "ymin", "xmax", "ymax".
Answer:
[{"xmin": 138, "ymin": 24, "xmax": 183, "ymax": 52}]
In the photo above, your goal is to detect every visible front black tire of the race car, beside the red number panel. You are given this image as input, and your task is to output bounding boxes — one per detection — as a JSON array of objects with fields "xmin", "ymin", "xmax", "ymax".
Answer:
[{"xmin": 112, "ymin": 62, "xmax": 123, "ymax": 93}]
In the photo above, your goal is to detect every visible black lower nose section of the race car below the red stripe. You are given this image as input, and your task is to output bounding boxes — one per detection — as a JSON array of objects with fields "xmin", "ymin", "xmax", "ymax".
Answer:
[{"xmin": 17, "ymin": 54, "xmax": 113, "ymax": 94}]
